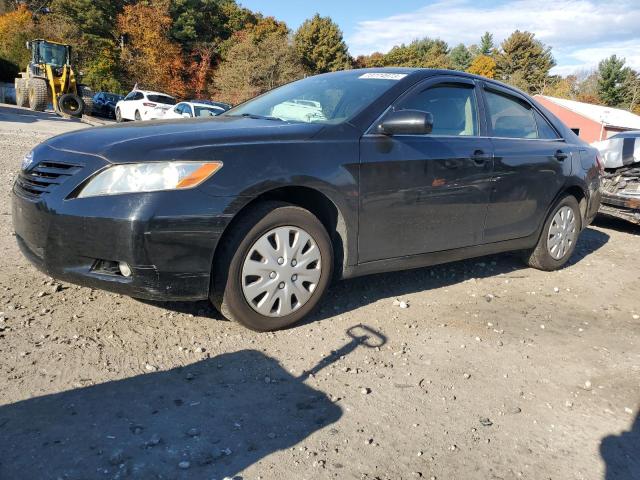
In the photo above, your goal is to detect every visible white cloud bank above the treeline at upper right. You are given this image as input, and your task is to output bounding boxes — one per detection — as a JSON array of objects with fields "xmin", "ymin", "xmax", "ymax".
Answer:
[{"xmin": 347, "ymin": 0, "xmax": 640, "ymax": 73}]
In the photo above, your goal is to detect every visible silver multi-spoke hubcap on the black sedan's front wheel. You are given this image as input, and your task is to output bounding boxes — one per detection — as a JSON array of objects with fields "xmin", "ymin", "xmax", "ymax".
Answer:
[{"xmin": 242, "ymin": 226, "xmax": 322, "ymax": 317}]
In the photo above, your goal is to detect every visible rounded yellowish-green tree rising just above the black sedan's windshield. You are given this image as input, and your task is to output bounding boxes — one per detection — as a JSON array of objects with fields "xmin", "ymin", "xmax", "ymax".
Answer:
[{"xmin": 293, "ymin": 13, "xmax": 351, "ymax": 74}]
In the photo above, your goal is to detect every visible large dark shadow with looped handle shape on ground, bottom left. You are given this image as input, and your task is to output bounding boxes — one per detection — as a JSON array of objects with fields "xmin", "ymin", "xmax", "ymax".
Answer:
[{"xmin": 0, "ymin": 327, "xmax": 386, "ymax": 479}]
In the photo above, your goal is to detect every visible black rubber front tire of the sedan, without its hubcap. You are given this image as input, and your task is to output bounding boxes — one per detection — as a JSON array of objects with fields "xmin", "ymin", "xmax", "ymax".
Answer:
[{"xmin": 209, "ymin": 201, "xmax": 333, "ymax": 332}]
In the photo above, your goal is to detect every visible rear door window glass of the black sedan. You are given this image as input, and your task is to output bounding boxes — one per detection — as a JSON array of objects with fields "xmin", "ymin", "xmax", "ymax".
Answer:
[{"xmin": 485, "ymin": 90, "xmax": 540, "ymax": 138}]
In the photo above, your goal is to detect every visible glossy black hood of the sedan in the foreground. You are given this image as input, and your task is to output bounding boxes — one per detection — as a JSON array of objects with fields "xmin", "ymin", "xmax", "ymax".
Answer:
[{"xmin": 42, "ymin": 116, "xmax": 322, "ymax": 163}]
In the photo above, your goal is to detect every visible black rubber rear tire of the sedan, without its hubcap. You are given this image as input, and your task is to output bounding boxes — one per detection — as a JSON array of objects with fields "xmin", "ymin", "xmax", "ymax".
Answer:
[{"xmin": 524, "ymin": 195, "xmax": 582, "ymax": 271}]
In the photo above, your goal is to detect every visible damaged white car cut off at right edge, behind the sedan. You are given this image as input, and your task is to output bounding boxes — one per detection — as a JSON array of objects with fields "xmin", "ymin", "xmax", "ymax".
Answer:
[{"xmin": 592, "ymin": 130, "xmax": 640, "ymax": 225}]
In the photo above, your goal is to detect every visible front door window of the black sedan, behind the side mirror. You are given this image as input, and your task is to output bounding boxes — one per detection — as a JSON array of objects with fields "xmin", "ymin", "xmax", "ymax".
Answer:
[{"xmin": 398, "ymin": 85, "xmax": 478, "ymax": 136}]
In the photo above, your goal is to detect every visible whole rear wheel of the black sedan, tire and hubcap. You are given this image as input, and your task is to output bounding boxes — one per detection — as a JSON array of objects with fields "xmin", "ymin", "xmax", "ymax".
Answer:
[{"xmin": 525, "ymin": 195, "xmax": 582, "ymax": 270}]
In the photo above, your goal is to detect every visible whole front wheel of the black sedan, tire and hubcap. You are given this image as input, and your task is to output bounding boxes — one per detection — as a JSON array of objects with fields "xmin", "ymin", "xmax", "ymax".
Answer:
[{"xmin": 210, "ymin": 202, "xmax": 333, "ymax": 332}]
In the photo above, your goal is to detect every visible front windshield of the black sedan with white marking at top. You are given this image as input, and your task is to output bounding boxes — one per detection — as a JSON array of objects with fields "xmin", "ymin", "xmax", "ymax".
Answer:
[{"xmin": 224, "ymin": 70, "xmax": 406, "ymax": 124}]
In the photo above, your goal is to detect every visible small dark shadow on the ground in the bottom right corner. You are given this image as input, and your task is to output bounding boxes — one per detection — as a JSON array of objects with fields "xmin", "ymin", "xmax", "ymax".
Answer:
[{"xmin": 600, "ymin": 413, "xmax": 640, "ymax": 480}]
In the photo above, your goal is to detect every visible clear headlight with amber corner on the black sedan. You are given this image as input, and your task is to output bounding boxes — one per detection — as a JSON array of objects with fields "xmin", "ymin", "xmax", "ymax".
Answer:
[{"xmin": 78, "ymin": 162, "xmax": 222, "ymax": 198}]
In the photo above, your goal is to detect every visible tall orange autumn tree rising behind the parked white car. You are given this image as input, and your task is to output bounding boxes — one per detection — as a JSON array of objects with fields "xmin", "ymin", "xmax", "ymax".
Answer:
[{"xmin": 117, "ymin": 3, "xmax": 187, "ymax": 96}]
